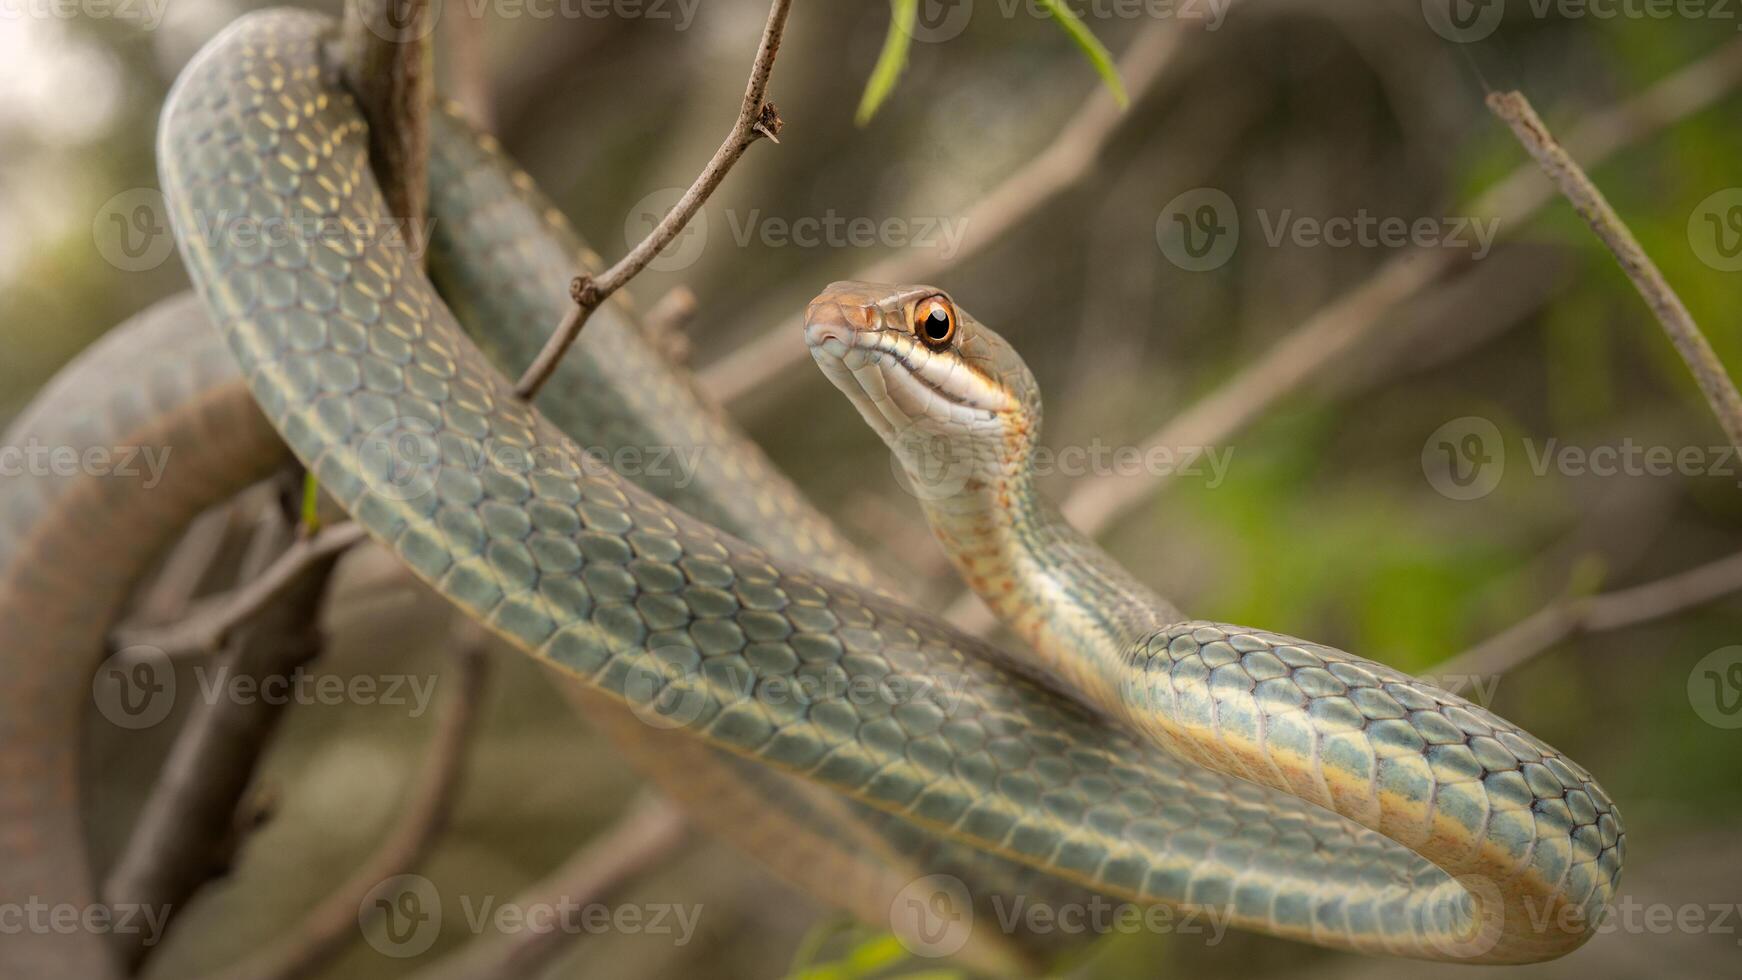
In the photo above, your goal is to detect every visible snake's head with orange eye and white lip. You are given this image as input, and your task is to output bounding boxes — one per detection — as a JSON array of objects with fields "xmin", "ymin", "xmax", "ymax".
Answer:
[{"xmin": 805, "ymin": 282, "xmax": 1040, "ymax": 498}]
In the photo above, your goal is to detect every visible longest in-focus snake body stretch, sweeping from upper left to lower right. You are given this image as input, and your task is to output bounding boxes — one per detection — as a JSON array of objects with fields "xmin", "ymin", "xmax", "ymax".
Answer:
[{"xmin": 159, "ymin": 12, "xmax": 1608, "ymax": 963}]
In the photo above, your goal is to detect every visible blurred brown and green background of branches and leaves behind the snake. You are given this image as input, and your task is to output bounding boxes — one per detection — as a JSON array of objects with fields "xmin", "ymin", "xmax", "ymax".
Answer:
[{"xmin": 0, "ymin": 0, "xmax": 1742, "ymax": 978}]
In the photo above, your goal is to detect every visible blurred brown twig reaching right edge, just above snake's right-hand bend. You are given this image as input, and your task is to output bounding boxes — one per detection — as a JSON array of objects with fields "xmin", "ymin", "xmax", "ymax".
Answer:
[{"xmin": 1434, "ymin": 554, "xmax": 1742, "ymax": 675}]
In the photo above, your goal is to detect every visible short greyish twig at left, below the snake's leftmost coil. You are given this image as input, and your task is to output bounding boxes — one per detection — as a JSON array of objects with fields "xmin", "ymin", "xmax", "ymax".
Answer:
[{"xmin": 111, "ymin": 520, "xmax": 364, "ymax": 658}]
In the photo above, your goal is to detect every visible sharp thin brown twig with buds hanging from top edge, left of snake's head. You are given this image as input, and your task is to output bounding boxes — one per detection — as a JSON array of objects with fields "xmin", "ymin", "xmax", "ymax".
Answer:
[{"xmin": 514, "ymin": 0, "xmax": 793, "ymax": 399}]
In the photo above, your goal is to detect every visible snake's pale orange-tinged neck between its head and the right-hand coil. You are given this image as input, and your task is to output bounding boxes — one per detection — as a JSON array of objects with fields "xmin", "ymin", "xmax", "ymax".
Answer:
[{"xmin": 922, "ymin": 463, "xmax": 1181, "ymax": 710}]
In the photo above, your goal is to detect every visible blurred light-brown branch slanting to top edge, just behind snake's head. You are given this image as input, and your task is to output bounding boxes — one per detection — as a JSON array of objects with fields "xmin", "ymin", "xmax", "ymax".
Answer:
[{"xmin": 697, "ymin": 19, "xmax": 1185, "ymax": 404}]
